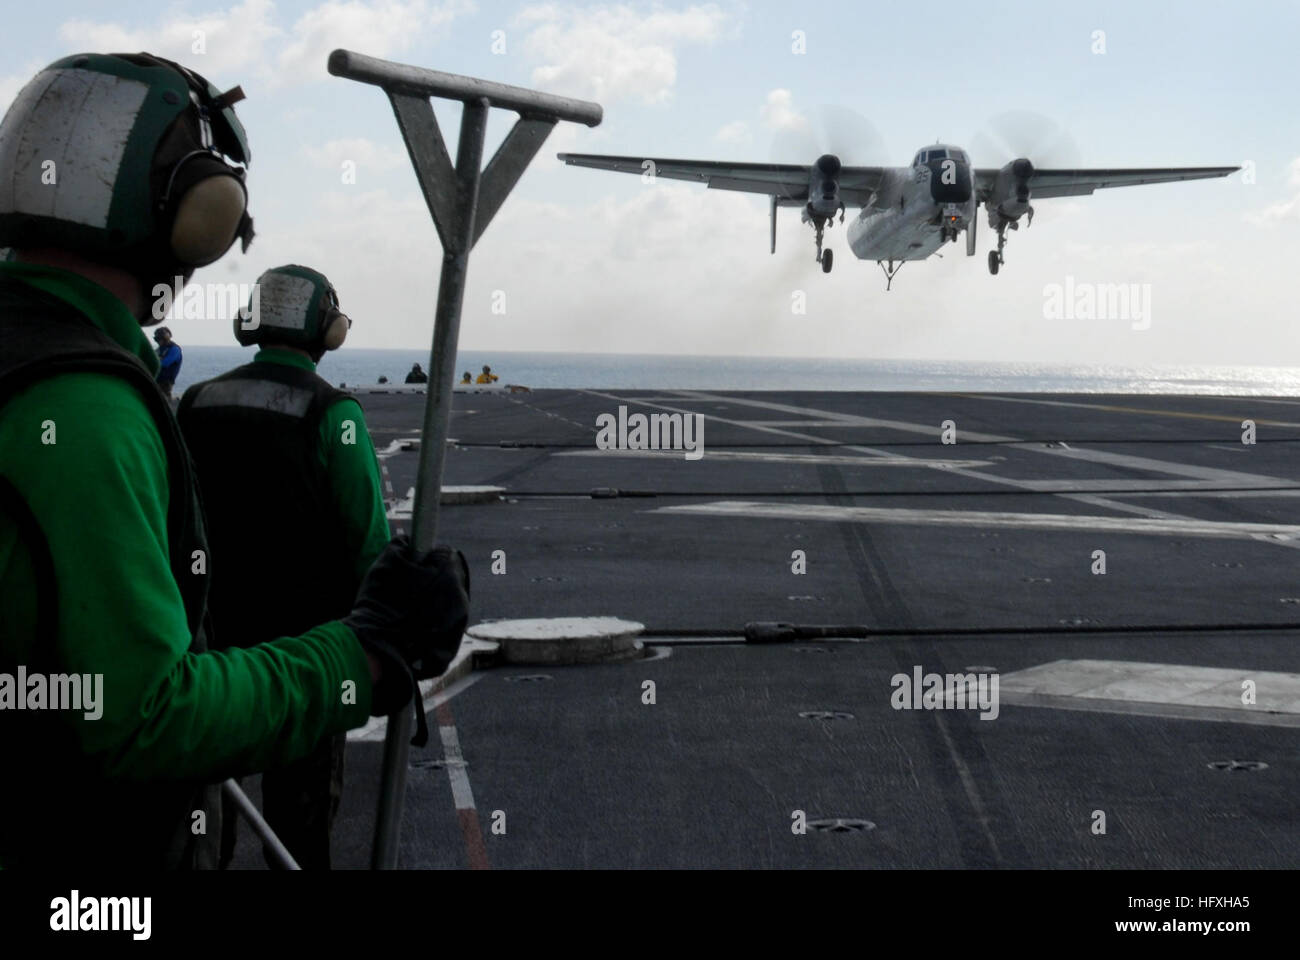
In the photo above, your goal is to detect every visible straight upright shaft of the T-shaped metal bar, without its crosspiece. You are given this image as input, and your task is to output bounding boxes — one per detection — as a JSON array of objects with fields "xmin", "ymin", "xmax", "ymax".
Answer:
[{"xmin": 371, "ymin": 99, "xmax": 489, "ymax": 870}]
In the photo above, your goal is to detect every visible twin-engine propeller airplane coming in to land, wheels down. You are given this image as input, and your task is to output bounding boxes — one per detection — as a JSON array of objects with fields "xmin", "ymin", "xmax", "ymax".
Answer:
[{"xmin": 558, "ymin": 143, "xmax": 1240, "ymax": 290}]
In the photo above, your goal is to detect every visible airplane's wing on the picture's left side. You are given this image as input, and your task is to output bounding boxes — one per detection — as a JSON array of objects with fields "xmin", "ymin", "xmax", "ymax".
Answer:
[{"xmin": 558, "ymin": 153, "xmax": 885, "ymax": 207}]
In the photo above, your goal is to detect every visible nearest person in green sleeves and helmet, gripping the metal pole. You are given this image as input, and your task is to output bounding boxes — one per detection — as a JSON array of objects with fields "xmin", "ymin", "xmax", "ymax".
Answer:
[{"xmin": 0, "ymin": 53, "xmax": 468, "ymax": 875}]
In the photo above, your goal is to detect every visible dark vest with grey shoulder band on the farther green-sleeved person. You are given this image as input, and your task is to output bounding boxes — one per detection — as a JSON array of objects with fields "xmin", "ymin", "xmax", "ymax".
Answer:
[{"xmin": 177, "ymin": 362, "xmax": 365, "ymax": 647}]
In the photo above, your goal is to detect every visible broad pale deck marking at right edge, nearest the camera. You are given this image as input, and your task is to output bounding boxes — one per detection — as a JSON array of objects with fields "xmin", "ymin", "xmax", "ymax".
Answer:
[{"xmin": 998, "ymin": 660, "xmax": 1300, "ymax": 727}]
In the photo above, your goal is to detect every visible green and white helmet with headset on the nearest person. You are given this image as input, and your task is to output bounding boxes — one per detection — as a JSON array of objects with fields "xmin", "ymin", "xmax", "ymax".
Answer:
[{"xmin": 0, "ymin": 53, "xmax": 252, "ymax": 286}]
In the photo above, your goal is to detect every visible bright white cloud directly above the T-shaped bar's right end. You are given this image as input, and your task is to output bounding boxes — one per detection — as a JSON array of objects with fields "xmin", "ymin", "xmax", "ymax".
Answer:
[{"xmin": 512, "ymin": 4, "xmax": 728, "ymax": 105}]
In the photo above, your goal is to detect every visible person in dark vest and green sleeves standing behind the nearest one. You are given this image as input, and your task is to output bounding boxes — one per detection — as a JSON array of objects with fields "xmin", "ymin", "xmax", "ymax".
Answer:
[{"xmin": 177, "ymin": 265, "xmax": 389, "ymax": 870}]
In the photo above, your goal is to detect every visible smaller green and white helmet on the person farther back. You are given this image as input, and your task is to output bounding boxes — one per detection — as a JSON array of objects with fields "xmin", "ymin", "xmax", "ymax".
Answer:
[{"xmin": 234, "ymin": 263, "xmax": 352, "ymax": 353}]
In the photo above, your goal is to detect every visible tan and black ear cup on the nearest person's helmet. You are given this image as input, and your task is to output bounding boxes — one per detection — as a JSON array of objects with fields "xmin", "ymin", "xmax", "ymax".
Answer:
[{"xmin": 164, "ymin": 153, "xmax": 248, "ymax": 267}]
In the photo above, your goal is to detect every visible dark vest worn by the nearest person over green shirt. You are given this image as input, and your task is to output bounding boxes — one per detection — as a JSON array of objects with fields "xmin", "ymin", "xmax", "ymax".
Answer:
[{"xmin": 0, "ymin": 281, "xmax": 221, "ymax": 869}]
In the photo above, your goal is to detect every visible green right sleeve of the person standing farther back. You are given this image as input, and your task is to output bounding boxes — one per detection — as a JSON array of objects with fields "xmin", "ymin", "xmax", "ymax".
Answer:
[{"xmin": 320, "ymin": 397, "xmax": 389, "ymax": 583}]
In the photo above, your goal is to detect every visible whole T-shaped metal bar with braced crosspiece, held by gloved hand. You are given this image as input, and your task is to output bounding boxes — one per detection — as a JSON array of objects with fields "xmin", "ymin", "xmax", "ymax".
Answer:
[{"xmin": 329, "ymin": 49, "xmax": 603, "ymax": 869}]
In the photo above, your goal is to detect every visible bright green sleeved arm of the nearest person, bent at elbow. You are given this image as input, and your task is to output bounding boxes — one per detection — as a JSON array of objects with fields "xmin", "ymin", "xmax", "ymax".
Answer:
[{"xmin": 0, "ymin": 373, "xmax": 372, "ymax": 780}]
